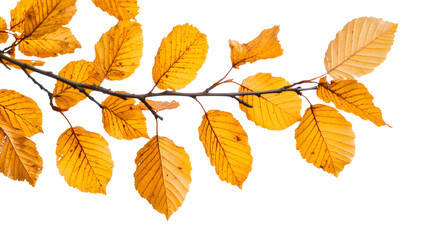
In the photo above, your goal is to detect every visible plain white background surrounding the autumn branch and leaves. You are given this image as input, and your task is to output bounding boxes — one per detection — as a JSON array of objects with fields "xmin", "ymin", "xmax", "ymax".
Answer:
[{"xmin": 0, "ymin": 0, "xmax": 429, "ymax": 240}]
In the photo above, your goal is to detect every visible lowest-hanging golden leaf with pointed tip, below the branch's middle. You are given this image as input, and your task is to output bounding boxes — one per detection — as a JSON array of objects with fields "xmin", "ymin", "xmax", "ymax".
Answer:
[{"xmin": 134, "ymin": 136, "xmax": 192, "ymax": 220}]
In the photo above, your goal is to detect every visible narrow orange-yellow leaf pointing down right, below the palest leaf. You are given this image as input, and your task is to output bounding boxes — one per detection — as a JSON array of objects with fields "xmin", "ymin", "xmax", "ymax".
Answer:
[{"xmin": 317, "ymin": 78, "xmax": 386, "ymax": 127}]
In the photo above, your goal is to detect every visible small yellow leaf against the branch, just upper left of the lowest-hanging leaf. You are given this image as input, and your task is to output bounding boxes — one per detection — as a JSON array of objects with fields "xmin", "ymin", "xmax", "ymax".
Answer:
[{"xmin": 102, "ymin": 93, "xmax": 149, "ymax": 140}]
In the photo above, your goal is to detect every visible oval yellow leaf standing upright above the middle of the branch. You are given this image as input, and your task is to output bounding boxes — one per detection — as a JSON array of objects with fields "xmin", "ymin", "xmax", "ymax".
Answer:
[{"xmin": 152, "ymin": 24, "xmax": 209, "ymax": 91}]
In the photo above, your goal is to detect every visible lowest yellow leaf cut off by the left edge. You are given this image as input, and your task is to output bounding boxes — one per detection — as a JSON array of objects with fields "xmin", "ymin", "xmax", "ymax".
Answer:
[{"xmin": 0, "ymin": 116, "xmax": 43, "ymax": 187}]
